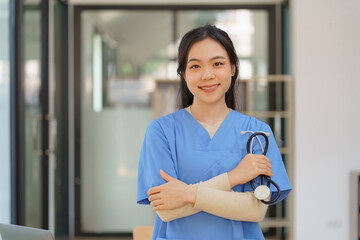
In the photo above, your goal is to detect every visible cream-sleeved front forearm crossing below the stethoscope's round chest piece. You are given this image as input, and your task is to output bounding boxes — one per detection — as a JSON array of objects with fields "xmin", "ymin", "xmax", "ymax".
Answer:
[{"xmin": 194, "ymin": 183, "xmax": 270, "ymax": 222}]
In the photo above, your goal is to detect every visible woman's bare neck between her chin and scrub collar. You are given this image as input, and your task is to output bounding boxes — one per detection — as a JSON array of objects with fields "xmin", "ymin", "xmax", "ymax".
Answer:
[{"xmin": 190, "ymin": 99, "xmax": 231, "ymax": 125}]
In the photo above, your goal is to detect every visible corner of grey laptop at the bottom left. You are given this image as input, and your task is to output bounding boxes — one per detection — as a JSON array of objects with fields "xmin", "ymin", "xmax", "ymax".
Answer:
[{"xmin": 0, "ymin": 223, "xmax": 54, "ymax": 240}]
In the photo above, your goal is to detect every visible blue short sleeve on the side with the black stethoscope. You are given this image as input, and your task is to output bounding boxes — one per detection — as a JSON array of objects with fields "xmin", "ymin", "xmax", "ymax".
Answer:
[{"xmin": 244, "ymin": 123, "xmax": 292, "ymax": 205}]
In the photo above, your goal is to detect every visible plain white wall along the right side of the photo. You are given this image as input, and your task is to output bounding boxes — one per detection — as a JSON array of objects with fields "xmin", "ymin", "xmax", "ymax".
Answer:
[{"xmin": 291, "ymin": 0, "xmax": 360, "ymax": 240}]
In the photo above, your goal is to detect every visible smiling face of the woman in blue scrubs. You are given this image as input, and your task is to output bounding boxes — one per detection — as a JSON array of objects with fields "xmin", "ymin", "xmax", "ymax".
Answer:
[{"xmin": 184, "ymin": 38, "xmax": 235, "ymax": 107}]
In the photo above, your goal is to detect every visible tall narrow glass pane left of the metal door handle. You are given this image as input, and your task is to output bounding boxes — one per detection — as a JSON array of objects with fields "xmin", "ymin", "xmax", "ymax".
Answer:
[{"xmin": 23, "ymin": 0, "xmax": 47, "ymax": 228}]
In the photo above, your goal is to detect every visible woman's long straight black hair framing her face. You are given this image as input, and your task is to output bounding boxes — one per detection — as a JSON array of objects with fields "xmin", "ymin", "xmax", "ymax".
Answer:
[{"xmin": 177, "ymin": 25, "xmax": 239, "ymax": 109}]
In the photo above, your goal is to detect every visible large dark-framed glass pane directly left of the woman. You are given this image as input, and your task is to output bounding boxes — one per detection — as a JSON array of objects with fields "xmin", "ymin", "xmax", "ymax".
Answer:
[{"xmin": 81, "ymin": 10, "xmax": 174, "ymax": 233}]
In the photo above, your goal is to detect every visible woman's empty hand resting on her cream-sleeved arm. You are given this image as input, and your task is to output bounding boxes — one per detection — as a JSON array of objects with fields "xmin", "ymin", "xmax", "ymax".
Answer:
[{"xmin": 148, "ymin": 170, "xmax": 197, "ymax": 211}]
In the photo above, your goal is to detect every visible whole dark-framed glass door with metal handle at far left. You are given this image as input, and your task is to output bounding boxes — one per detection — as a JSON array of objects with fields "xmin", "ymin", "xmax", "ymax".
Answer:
[{"xmin": 11, "ymin": 0, "xmax": 68, "ymax": 236}]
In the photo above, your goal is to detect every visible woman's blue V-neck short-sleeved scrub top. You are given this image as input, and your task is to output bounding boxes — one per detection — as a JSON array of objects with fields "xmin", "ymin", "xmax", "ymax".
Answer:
[{"xmin": 137, "ymin": 109, "xmax": 291, "ymax": 240}]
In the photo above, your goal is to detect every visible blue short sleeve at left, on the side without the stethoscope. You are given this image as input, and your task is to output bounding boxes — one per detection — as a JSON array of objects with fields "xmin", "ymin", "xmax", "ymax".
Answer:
[{"xmin": 137, "ymin": 120, "xmax": 177, "ymax": 204}]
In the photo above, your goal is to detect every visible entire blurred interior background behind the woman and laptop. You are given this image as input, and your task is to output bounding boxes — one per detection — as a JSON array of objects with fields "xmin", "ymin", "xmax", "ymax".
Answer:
[{"xmin": 0, "ymin": 0, "xmax": 360, "ymax": 240}]
